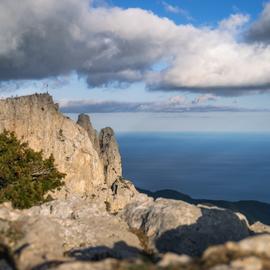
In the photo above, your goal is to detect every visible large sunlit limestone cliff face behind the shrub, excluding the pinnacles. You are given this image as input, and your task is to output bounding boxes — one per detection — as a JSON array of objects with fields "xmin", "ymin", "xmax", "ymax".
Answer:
[{"xmin": 0, "ymin": 94, "xmax": 105, "ymax": 194}]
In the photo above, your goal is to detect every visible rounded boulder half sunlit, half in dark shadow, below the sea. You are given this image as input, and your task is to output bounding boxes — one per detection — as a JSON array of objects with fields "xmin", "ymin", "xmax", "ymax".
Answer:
[{"xmin": 121, "ymin": 199, "xmax": 250, "ymax": 256}]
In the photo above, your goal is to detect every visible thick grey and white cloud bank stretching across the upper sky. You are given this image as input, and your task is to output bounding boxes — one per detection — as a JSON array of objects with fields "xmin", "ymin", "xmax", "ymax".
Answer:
[{"xmin": 0, "ymin": 0, "xmax": 270, "ymax": 95}]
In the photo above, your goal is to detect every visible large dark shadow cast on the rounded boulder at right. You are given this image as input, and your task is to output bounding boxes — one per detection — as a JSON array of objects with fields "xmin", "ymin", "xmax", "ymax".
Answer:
[{"xmin": 155, "ymin": 208, "xmax": 250, "ymax": 256}]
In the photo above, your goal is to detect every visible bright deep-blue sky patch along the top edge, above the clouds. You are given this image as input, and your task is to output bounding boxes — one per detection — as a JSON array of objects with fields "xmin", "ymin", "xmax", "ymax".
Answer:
[{"xmin": 108, "ymin": 0, "xmax": 266, "ymax": 25}]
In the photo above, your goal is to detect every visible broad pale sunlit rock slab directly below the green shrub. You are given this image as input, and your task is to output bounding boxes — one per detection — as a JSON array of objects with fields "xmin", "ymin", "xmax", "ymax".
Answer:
[{"xmin": 0, "ymin": 197, "xmax": 142, "ymax": 269}]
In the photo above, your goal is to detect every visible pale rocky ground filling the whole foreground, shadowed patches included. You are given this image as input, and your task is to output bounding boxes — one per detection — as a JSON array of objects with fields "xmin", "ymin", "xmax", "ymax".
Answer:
[{"xmin": 0, "ymin": 190, "xmax": 270, "ymax": 270}]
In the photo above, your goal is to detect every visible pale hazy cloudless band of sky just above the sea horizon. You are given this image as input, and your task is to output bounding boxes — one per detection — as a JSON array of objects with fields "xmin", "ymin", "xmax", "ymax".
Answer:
[{"xmin": 65, "ymin": 112, "xmax": 270, "ymax": 133}]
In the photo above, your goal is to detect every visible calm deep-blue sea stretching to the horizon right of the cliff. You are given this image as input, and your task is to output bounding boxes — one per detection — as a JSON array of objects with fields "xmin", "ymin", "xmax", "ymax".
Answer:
[{"xmin": 117, "ymin": 133, "xmax": 270, "ymax": 202}]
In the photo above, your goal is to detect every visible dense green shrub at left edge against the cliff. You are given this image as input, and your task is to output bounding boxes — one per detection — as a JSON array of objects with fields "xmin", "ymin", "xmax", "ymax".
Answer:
[{"xmin": 0, "ymin": 131, "xmax": 65, "ymax": 209}]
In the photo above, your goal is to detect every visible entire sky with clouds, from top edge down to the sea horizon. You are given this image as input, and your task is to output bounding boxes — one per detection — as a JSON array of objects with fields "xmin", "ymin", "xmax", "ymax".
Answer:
[{"xmin": 0, "ymin": 0, "xmax": 270, "ymax": 132}]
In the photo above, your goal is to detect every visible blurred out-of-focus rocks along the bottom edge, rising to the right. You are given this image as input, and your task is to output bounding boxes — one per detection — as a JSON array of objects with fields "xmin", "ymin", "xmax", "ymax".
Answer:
[{"xmin": 49, "ymin": 235, "xmax": 270, "ymax": 270}]
